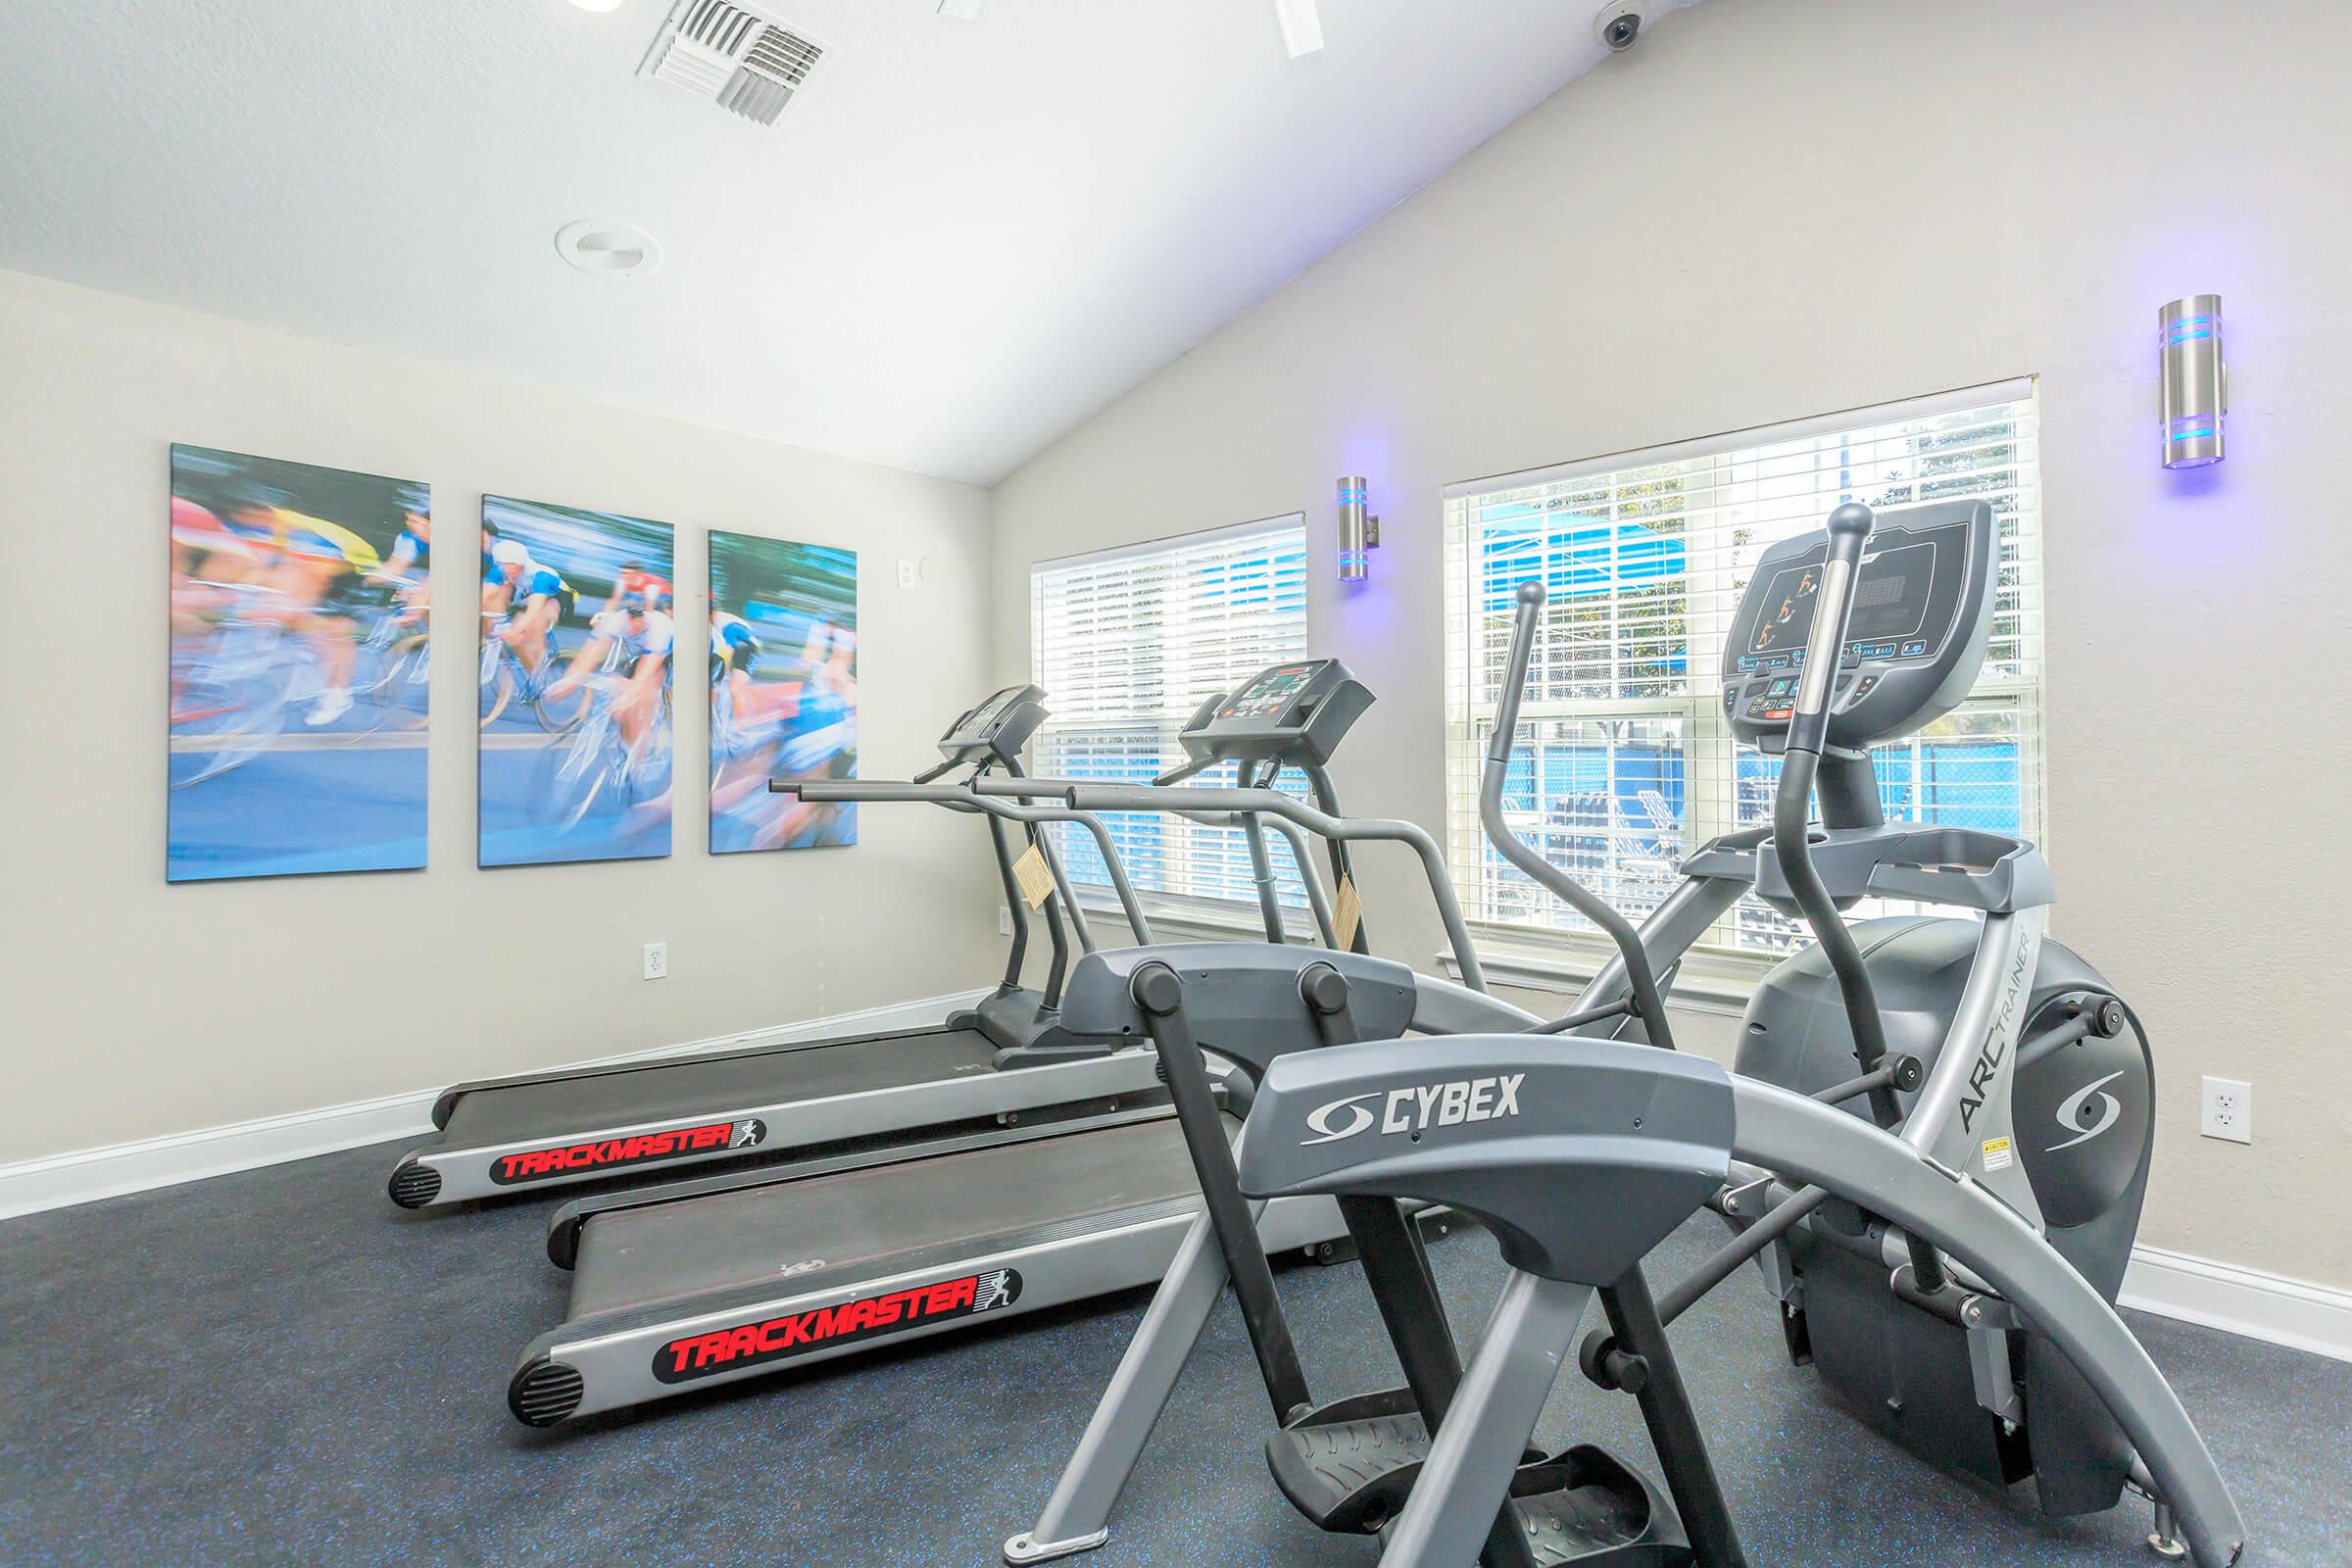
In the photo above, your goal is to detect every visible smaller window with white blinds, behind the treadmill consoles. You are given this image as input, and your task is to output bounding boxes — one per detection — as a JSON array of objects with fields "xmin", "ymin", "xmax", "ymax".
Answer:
[{"xmin": 1030, "ymin": 513, "xmax": 1307, "ymax": 909}]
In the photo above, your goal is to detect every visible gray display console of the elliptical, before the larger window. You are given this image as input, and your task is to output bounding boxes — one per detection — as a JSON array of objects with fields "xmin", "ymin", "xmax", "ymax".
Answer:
[{"xmin": 1724, "ymin": 501, "xmax": 1999, "ymax": 753}]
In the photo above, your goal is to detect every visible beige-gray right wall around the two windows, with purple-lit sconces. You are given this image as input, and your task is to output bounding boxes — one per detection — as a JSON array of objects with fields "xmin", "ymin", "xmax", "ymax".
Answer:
[{"xmin": 995, "ymin": 0, "xmax": 2352, "ymax": 1284}]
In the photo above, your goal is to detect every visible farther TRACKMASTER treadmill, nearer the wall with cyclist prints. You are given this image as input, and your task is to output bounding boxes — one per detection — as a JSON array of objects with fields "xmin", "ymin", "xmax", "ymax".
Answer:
[{"xmin": 388, "ymin": 686, "xmax": 1159, "ymax": 1208}]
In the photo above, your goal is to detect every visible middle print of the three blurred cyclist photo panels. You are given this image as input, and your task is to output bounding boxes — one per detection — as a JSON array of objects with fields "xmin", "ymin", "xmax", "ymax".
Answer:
[{"xmin": 480, "ymin": 496, "xmax": 677, "ymax": 865}]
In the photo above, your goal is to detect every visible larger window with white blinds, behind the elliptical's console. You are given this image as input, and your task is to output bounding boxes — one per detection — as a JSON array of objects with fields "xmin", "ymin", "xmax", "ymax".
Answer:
[{"xmin": 1446, "ymin": 381, "xmax": 2041, "ymax": 955}]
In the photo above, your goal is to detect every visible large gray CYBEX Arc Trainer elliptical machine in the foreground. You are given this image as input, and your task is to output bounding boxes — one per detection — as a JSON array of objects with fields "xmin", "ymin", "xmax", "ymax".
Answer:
[{"xmin": 1237, "ymin": 503, "xmax": 2246, "ymax": 1568}]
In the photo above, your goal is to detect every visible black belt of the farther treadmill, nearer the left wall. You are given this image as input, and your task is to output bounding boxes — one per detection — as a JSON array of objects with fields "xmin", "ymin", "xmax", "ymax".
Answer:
[{"xmin": 442, "ymin": 1030, "xmax": 998, "ymax": 1145}]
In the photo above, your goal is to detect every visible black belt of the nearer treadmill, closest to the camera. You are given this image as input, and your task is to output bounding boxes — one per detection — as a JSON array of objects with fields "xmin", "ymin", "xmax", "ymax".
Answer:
[{"xmin": 566, "ymin": 1116, "xmax": 1237, "ymax": 1324}]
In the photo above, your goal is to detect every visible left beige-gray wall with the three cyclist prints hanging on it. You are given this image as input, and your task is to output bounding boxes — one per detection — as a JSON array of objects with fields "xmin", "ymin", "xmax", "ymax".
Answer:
[{"xmin": 0, "ymin": 272, "xmax": 1002, "ymax": 1163}]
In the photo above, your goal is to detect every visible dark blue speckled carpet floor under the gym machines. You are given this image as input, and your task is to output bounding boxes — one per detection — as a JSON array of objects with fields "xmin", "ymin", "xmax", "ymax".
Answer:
[{"xmin": 0, "ymin": 1148, "xmax": 2352, "ymax": 1568}]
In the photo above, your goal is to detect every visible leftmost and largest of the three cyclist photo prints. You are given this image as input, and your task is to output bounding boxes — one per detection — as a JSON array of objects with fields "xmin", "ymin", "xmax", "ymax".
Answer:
[{"xmin": 165, "ymin": 447, "xmax": 433, "ymax": 882}]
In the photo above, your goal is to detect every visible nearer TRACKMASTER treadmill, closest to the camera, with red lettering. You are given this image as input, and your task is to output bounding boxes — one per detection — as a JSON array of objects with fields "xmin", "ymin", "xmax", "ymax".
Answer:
[{"xmin": 494, "ymin": 661, "xmax": 1373, "ymax": 1427}]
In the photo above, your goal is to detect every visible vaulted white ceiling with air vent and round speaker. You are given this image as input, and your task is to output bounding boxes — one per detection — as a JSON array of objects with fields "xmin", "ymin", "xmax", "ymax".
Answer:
[{"xmin": 0, "ymin": 0, "xmax": 1687, "ymax": 482}]
